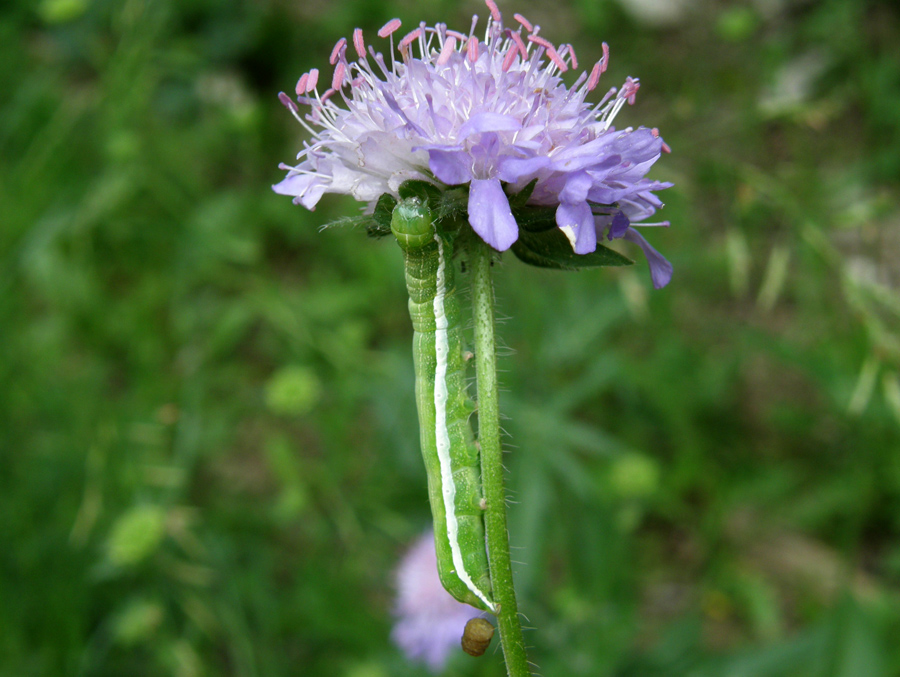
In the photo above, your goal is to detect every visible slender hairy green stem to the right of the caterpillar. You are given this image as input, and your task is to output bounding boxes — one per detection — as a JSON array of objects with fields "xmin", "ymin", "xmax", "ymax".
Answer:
[{"xmin": 469, "ymin": 237, "xmax": 531, "ymax": 677}]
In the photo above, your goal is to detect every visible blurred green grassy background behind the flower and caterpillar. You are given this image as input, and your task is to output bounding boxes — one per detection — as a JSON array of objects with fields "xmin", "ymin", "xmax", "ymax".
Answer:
[{"xmin": 0, "ymin": 0, "xmax": 900, "ymax": 677}]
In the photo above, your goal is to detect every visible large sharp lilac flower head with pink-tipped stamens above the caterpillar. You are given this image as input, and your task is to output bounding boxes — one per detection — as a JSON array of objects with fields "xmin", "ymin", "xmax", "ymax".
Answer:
[{"xmin": 273, "ymin": 0, "xmax": 672, "ymax": 288}]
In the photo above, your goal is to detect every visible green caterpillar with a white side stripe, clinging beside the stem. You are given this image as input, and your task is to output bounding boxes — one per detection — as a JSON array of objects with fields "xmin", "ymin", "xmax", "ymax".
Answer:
[{"xmin": 391, "ymin": 197, "xmax": 497, "ymax": 612}]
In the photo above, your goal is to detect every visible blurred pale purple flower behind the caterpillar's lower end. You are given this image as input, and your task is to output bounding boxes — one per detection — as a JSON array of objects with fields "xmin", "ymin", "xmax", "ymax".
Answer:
[{"xmin": 391, "ymin": 531, "xmax": 480, "ymax": 672}]
